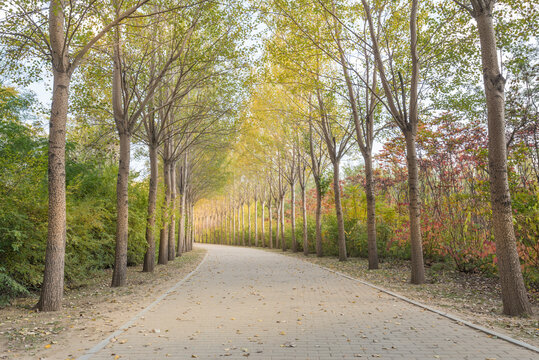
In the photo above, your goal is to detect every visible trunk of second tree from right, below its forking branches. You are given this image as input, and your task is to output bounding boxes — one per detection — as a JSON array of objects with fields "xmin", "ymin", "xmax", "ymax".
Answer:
[{"xmin": 404, "ymin": 131, "xmax": 425, "ymax": 284}]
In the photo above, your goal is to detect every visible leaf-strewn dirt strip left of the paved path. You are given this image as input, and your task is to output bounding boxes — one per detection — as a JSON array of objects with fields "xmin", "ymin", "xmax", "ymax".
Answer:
[{"xmin": 0, "ymin": 249, "xmax": 206, "ymax": 359}]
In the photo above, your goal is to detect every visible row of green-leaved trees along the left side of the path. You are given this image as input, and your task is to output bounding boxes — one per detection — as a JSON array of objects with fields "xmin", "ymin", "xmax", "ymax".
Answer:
[{"xmin": 0, "ymin": 0, "xmax": 248, "ymax": 311}]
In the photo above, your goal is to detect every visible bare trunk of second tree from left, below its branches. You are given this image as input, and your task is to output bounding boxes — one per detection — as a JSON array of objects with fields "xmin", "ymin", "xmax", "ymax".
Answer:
[{"xmin": 111, "ymin": 129, "xmax": 131, "ymax": 287}]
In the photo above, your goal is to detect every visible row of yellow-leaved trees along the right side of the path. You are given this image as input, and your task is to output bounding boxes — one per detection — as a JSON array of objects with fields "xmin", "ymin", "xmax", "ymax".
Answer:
[{"xmin": 196, "ymin": 0, "xmax": 537, "ymax": 315}]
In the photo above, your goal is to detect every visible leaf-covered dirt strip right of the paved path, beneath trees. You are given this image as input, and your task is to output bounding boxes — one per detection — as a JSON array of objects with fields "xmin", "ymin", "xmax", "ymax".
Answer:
[{"xmin": 269, "ymin": 249, "xmax": 539, "ymax": 347}]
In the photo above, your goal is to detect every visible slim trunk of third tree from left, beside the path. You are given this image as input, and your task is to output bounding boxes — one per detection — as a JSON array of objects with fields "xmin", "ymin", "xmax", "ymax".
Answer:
[{"xmin": 142, "ymin": 145, "xmax": 158, "ymax": 272}]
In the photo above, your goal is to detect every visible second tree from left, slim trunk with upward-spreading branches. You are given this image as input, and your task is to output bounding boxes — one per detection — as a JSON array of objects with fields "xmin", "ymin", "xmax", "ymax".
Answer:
[{"xmin": 111, "ymin": 2, "xmax": 198, "ymax": 287}]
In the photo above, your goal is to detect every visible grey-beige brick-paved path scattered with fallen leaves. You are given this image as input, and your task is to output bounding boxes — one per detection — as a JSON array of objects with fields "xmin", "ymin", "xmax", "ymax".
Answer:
[{"xmin": 82, "ymin": 245, "xmax": 539, "ymax": 360}]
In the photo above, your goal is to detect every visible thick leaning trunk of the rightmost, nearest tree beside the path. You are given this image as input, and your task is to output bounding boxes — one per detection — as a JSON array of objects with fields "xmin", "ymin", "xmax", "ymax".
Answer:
[{"xmin": 472, "ymin": 7, "xmax": 532, "ymax": 315}]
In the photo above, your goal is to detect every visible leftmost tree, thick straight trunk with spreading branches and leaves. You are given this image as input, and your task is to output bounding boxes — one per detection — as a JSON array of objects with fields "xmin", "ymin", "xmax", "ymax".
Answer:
[{"xmin": 2, "ymin": 0, "xmax": 149, "ymax": 311}]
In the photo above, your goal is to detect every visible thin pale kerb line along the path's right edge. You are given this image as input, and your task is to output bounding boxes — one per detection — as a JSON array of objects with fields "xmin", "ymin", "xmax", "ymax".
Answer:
[{"xmin": 288, "ymin": 253, "xmax": 539, "ymax": 353}]
